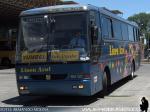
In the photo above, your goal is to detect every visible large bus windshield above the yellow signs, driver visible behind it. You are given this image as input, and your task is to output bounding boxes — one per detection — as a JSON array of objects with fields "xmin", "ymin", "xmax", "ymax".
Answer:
[{"xmin": 20, "ymin": 13, "xmax": 87, "ymax": 52}]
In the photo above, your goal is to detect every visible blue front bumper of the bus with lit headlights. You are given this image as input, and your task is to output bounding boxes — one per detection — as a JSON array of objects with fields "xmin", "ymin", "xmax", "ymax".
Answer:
[{"xmin": 18, "ymin": 80, "xmax": 92, "ymax": 96}]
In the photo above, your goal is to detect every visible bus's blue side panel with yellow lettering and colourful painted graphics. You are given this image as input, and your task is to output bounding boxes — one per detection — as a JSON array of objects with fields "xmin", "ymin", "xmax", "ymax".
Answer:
[{"xmin": 99, "ymin": 40, "xmax": 140, "ymax": 84}]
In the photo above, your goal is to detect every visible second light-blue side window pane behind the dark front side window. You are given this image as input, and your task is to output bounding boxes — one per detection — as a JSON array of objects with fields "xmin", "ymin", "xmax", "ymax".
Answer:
[{"xmin": 121, "ymin": 23, "xmax": 129, "ymax": 40}]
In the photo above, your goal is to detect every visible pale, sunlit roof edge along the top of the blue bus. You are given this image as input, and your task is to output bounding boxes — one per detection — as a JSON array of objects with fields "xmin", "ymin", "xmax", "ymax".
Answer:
[{"xmin": 20, "ymin": 4, "xmax": 138, "ymax": 27}]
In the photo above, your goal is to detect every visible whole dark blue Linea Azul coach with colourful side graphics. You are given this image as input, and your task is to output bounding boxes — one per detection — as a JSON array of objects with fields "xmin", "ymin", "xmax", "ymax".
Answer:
[{"xmin": 16, "ymin": 4, "xmax": 140, "ymax": 96}]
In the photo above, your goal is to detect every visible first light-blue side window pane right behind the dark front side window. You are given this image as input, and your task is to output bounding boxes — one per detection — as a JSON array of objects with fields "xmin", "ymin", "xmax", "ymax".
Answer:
[{"xmin": 113, "ymin": 20, "xmax": 122, "ymax": 40}]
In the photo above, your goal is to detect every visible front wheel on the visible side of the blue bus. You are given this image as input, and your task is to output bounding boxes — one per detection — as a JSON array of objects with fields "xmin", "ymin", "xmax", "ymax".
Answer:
[{"xmin": 102, "ymin": 71, "xmax": 108, "ymax": 96}]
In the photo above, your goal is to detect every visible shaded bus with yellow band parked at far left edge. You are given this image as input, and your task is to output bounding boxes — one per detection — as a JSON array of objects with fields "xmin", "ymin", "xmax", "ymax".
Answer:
[{"xmin": 0, "ymin": 29, "xmax": 17, "ymax": 67}]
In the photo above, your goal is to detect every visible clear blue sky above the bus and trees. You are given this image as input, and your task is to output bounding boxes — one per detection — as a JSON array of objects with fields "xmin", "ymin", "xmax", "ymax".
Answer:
[{"xmin": 66, "ymin": 0, "xmax": 150, "ymax": 18}]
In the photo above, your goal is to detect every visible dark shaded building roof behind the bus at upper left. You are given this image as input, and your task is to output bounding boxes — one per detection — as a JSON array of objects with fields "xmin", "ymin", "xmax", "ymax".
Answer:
[{"xmin": 0, "ymin": 0, "xmax": 76, "ymax": 38}]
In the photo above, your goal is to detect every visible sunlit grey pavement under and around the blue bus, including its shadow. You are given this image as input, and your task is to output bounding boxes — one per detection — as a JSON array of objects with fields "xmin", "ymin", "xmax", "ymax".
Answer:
[{"xmin": 0, "ymin": 64, "xmax": 150, "ymax": 112}]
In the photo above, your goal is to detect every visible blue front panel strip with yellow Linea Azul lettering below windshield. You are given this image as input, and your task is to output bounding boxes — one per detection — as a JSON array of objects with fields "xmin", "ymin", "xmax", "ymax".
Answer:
[{"xmin": 16, "ymin": 62, "xmax": 90, "ymax": 75}]
